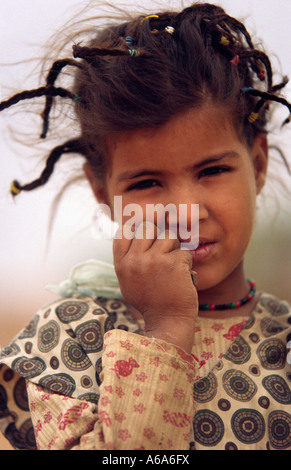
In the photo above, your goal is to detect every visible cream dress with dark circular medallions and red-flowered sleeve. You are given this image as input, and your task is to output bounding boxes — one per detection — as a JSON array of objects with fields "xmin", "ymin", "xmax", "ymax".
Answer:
[{"xmin": 0, "ymin": 294, "xmax": 291, "ymax": 450}]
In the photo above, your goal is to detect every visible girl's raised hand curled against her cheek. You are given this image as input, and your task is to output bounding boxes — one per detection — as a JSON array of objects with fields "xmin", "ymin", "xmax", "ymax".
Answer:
[{"xmin": 113, "ymin": 224, "xmax": 198, "ymax": 353}]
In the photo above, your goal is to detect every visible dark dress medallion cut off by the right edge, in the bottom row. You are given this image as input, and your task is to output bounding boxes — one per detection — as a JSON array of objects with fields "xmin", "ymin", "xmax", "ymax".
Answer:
[{"xmin": 268, "ymin": 411, "xmax": 291, "ymax": 449}]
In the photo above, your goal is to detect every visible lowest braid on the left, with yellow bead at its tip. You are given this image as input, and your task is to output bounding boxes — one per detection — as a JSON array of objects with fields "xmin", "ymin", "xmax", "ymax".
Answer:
[{"xmin": 11, "ymin": 139, "xmax": 86, "ymax": 196}]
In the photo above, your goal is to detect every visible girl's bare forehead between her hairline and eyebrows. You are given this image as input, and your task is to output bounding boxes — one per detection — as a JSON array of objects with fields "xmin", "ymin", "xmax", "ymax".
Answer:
[{"xmin": 107, "ymin": 106, "xmax": 243, "ymax": 176}]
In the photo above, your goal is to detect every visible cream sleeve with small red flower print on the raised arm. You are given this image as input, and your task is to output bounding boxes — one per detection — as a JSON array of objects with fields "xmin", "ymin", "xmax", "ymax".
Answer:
[{"xmin": 28, "ymin": 329, "xmax": 194, "ymax": 450}]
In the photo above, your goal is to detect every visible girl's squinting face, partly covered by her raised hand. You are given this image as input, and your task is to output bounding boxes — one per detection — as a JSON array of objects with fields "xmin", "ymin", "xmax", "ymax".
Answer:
[{"xmin": 87, "ymin": 106, "xmax": 267, "ymax": 291}]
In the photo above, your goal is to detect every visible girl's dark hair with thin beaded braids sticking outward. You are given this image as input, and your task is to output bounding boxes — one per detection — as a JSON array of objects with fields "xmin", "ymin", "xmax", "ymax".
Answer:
[{"xmin": 0, "ymin": 3, "xmax": 291, "ymax": 195}]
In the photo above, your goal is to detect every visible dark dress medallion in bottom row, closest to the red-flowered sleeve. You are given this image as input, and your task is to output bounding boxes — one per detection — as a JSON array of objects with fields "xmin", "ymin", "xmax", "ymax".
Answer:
[{"xmin": 193, "ymin": 410, "xmax": 224, "ymax": 447}]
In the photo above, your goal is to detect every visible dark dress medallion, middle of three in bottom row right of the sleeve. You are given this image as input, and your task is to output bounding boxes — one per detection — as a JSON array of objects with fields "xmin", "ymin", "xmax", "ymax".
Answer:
[{"xmin": 231, "ymin": 408, "xmax": 265, "ymax": 444}]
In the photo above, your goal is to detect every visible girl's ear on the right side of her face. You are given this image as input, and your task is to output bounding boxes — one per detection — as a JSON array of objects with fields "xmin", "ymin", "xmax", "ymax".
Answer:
[{"xmin": 252, "ymin": 133, "xmax": 268, "ymax": 194}]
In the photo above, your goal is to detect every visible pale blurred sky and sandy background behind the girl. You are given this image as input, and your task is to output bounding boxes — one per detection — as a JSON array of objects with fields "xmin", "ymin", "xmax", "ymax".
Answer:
[{"xmin": 0, "ymin": 0, "xmax": 291, "ymax": 449}]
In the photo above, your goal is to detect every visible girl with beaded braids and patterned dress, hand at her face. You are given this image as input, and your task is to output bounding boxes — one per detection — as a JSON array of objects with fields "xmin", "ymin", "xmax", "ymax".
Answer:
[{"xmin": 0, "ymin": 3, "xmax": 291, "ymax": 450}]
